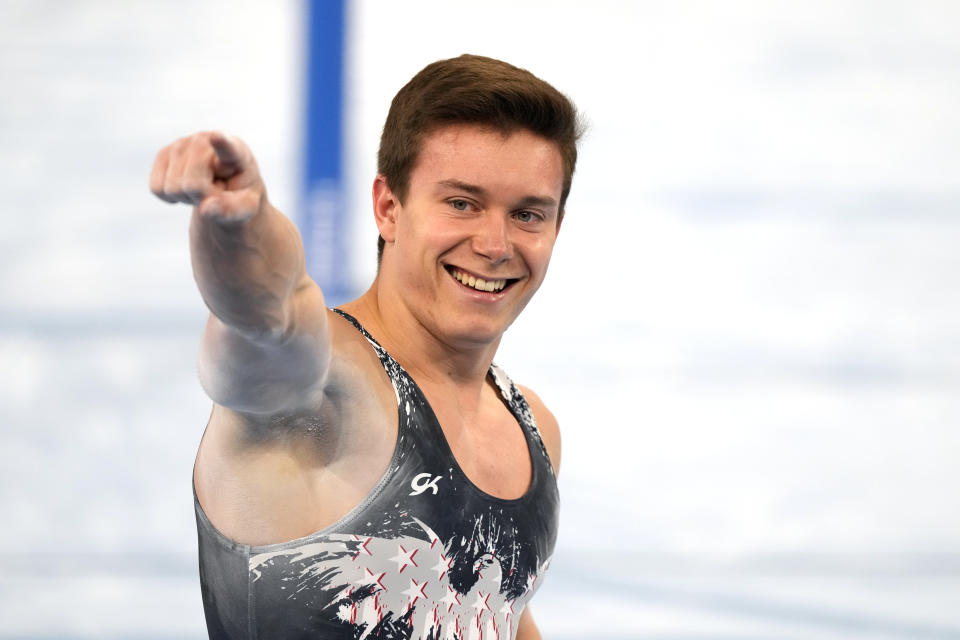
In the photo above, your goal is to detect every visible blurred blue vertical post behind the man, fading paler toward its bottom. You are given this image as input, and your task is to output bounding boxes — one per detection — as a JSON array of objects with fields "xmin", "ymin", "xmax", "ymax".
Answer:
[{"xmin": 300, "ymin": 0, "xmax": 351, "ymax": 305}]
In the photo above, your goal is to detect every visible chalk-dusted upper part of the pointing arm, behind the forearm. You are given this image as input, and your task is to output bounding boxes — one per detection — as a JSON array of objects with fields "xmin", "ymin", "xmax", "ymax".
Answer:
[{"xmin": 198, "ymin": 283, "xmax": 331, "ymax": 414}]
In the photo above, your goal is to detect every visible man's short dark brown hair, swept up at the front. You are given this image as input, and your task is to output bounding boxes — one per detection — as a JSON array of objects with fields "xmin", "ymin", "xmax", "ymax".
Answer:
[{"xmin": 377, "ymin": 54, "xmax": 582, "ymax": 265}]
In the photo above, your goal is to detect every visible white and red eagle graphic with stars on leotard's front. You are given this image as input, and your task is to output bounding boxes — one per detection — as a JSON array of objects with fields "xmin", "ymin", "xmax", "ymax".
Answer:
[{"xmin": 250, "ymin": 518, "xmax": 549, "ymax": 640}]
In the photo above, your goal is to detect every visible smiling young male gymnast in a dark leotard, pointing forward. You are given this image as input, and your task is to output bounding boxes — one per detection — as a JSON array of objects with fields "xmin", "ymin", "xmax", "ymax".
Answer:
[{"xmin": 150, "ymin": 56, "xmax": 579, "ymax": 640}]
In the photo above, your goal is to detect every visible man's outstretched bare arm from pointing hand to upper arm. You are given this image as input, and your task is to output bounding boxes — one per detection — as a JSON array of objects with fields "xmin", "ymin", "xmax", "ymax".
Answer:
[{"xmin": 150, "ymin": 132, "xmax": 330, "ymax": 415}]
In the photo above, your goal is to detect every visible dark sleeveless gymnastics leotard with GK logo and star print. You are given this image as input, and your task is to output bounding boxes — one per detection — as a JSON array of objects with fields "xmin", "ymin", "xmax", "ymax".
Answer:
[{"xmin": 194, "ymin": 309, "xmax": 559, "ymax": 640}]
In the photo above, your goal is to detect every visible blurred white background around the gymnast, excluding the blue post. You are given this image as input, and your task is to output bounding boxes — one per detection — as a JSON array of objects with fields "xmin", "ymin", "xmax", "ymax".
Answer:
[{"xmin": 0, "ymin": 0, "xmax": 960, "ymax": 640}]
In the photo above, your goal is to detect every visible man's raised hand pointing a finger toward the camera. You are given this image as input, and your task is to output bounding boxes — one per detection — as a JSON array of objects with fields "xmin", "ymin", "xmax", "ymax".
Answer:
[{"xmin": 150, "ymin": 131, "xmax": 266, "ymax": 224}]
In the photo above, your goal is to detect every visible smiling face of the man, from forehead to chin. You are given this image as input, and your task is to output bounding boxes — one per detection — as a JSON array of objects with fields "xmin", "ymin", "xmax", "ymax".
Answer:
[{"xmin": 385, "ymin": 125, "xmax": 563, "ymax": 346}]
